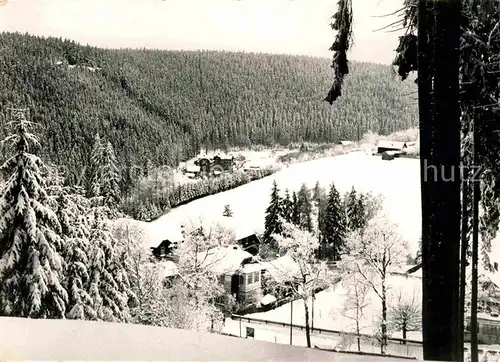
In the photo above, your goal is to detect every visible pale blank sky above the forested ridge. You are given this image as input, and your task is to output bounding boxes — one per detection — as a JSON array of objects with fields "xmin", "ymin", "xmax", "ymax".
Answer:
[{"xmin": 0, "ymin": 0, "xmax": 402, "ymax": 63}]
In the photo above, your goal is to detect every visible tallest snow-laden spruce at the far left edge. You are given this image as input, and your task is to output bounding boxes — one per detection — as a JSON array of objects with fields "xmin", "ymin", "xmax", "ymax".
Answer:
[{"xmin": 0, "ymin": 110, "xmax": 68, "ymax": 318}]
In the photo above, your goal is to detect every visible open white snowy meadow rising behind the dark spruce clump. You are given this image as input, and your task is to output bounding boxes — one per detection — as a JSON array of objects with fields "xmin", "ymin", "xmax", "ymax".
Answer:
[{"xmin": 140, "ymin": 152, "xmax": 421, "ymax": 253}]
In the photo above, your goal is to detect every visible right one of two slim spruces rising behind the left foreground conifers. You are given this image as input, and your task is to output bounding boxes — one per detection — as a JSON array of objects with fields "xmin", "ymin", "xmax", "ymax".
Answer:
[{"xmin": 101, "ymin": 142, "xmax": 120, "ymax": 209}]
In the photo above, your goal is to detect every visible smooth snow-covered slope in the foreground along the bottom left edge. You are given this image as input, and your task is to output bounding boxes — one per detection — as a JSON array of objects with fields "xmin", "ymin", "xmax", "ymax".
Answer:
[{"xmin": 0, "ymin": 317, "xmax": 368, "ymax": 362}]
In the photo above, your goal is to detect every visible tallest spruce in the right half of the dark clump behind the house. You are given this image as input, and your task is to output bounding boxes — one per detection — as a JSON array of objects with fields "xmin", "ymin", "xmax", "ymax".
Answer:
[{"xmin": 324, "ymin": 183, "xmax": 346, "ymax": 260}]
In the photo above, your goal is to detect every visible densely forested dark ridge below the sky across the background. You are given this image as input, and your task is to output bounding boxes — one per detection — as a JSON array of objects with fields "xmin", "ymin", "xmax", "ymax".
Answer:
[{"xmin": 0, "ymin": 33, "xmax": 417, "ymax": 183}]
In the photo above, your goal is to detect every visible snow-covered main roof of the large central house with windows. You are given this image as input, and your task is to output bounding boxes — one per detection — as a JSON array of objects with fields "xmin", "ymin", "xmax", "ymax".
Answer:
[{"xmin": 199, "ymin": 245, "xmax": 253, "ymax": 274}]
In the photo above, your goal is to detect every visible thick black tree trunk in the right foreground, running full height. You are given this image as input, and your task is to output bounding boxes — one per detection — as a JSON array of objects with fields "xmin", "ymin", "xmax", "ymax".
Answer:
[{"xmin": 418, "ymin": 0, "xmax": 460, "ymax": 361}]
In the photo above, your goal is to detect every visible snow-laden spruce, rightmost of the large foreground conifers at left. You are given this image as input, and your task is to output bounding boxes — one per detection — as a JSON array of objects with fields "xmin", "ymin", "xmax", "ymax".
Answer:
[{"xmin": 87, "ymin": 208, "xmax": 130, "ymax": 321}]
